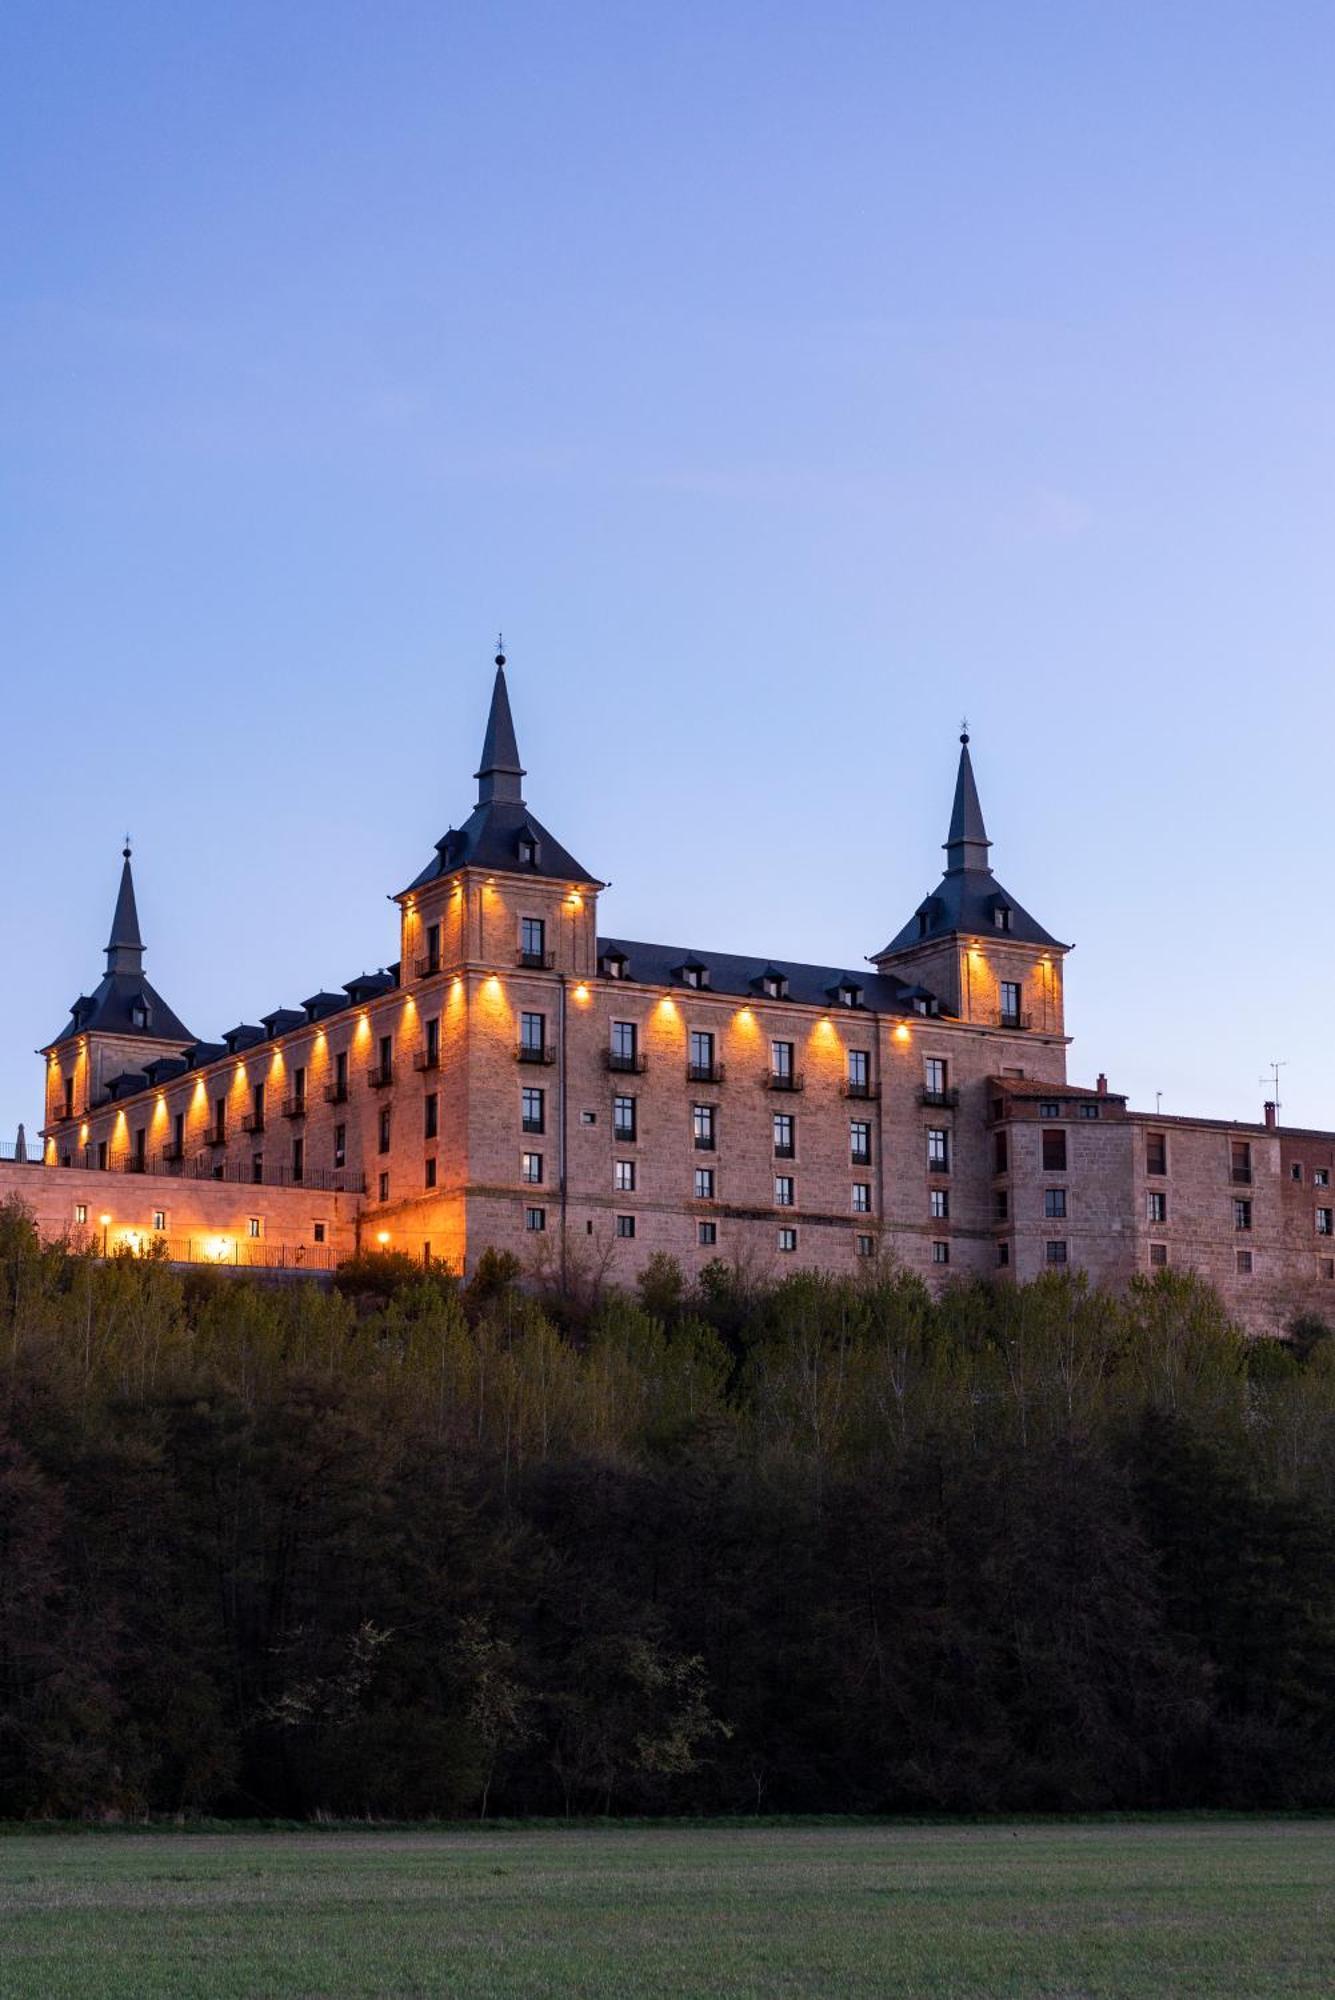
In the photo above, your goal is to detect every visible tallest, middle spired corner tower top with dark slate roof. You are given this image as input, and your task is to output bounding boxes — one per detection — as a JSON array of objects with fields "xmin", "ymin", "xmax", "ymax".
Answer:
[{"xmin": 398, "ymin": 652, "xmax": 604, "ymax": 984}]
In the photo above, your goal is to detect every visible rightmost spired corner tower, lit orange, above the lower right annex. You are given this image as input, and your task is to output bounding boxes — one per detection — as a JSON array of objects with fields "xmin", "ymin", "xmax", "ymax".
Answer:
[{"xmin": 869, "ymin": 730, "xmax": 1069, "ymax": 1040}]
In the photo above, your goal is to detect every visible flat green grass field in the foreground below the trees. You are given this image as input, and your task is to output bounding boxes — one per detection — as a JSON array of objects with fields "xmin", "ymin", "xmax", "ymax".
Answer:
[{"xmin": 0, "ymin": 1820, "xmax": 1335, "ymax": 2000}]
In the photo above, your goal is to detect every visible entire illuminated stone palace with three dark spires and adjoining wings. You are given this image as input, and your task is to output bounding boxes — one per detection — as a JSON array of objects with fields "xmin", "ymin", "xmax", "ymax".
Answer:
[{"xmin": 10, "ymin": 656, "xmax": 1335, "ymax": 1330}]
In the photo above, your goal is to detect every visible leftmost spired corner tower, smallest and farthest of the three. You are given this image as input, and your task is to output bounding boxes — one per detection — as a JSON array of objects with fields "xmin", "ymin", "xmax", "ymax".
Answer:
[{"xmin": 42, "ymin": 840, "xmax": 194, "ymax": 1152}]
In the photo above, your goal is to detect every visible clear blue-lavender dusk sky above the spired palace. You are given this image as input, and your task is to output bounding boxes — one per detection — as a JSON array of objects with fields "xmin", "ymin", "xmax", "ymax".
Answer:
[{"xmin": 0, "ymin": 0, "xmax": 1335, "ymax": 1134}]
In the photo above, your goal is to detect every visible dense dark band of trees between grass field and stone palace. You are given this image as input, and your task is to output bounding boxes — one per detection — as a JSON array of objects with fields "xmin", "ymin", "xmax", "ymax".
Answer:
[{"xmin": 0, "ymin": 1204, "xmax": 1335, "ymax": 1818}]
